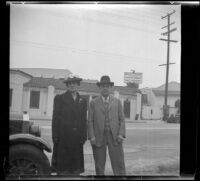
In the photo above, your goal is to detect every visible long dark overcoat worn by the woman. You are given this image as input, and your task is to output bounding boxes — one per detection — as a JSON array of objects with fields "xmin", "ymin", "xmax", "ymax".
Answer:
[{"xmin": 52, "ymin": 91, "xmax": 87, "ymax": 174}]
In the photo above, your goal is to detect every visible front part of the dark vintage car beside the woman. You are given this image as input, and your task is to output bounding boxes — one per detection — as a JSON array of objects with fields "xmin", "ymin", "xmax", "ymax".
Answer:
[{"xmin": 6, "ymin": 120, "xmax": 52, "ymax": 176}]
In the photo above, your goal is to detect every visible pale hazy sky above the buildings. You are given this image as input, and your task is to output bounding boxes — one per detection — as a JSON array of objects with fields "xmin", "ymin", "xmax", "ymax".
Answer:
[{"xmin": 10, "ymin": 4, "xmax": 181, "ymax": 88}]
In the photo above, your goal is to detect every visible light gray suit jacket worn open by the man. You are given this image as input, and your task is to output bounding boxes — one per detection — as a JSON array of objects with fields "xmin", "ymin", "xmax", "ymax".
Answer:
[{"xmin": 88, "ymin": 95, "xmax": 126, "ymax": 146}]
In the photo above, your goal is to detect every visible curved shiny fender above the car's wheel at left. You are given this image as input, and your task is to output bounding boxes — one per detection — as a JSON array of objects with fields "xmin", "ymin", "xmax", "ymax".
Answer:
[{"xmin": 9, "ymin": 133, "xmax": 52, "ymax": 152}]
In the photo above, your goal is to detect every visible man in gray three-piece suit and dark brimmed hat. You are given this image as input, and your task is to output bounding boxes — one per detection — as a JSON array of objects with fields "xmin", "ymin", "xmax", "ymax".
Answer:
[{"xmin": 88, "ymin": 76, "xmax": 126, "ymax": 175}]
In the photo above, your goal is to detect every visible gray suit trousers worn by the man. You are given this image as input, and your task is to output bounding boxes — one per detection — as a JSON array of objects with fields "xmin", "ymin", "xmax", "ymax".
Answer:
[{"xmin": 92, "ymin": 130, "xmax": 126, "ymax": 175}]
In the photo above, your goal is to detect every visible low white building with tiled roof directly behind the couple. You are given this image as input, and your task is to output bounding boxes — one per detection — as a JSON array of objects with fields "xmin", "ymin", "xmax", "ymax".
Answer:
[{"xmin": 10, "ymin": 69, "xmax": 141, "ymax": 121}]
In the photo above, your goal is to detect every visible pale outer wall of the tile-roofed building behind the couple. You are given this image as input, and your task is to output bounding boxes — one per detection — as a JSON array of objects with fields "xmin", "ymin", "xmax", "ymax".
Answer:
[{"xmin": 13, "ymin": 84, "xmax": 141, "ymax": 121}]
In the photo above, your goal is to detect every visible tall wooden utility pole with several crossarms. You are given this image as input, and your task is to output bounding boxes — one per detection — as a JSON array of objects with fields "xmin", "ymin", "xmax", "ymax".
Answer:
[{"xmin": 159, "ymin": 10, "xmax": 178, "ymax": 121}]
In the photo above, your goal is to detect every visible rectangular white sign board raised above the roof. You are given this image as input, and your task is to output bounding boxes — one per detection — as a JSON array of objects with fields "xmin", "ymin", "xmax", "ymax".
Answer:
[{"xmin": 124, "ymin": 72, "xmax": 142, "ymax": 84}]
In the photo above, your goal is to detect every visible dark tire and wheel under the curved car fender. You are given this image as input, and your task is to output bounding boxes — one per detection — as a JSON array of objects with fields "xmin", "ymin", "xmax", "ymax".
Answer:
[{"xmin": 9, "ymin": 144, "xmax": 50, "ymax": 176}]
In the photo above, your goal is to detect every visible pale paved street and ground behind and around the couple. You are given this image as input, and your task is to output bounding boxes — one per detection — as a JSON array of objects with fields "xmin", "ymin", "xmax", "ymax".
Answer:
[{"xmin": 35, "ymin": 120, "xmax": 180, "ymax": 175}]
